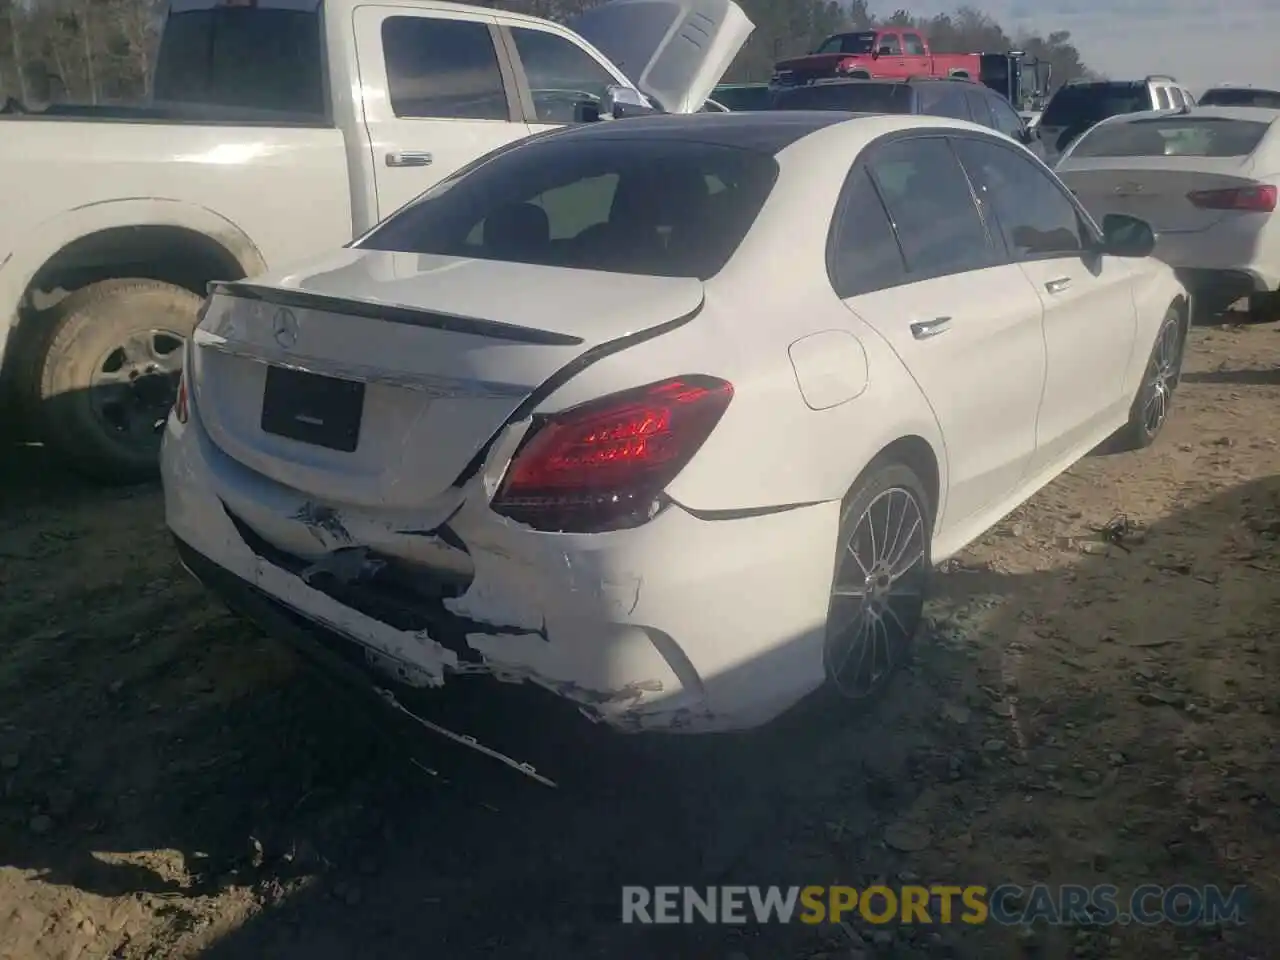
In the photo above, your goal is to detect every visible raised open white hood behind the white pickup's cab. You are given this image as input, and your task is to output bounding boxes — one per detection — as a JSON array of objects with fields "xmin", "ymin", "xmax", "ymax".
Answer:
[{"xmin": 568, "ymin": 0, "xmax": 755, "ymax": 114}]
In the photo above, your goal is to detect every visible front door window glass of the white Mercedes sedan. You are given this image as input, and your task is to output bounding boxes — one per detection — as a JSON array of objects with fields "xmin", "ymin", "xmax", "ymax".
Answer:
[{"xmin": 955, "ymin": 138, "xmax": 1085, "ymax": 260}]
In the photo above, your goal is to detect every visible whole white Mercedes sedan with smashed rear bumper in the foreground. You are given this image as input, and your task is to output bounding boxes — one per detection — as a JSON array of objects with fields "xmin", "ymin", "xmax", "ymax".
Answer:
[{"xmin": 163, "ymin": 111, "xmax": 1187, "ymax": 732}]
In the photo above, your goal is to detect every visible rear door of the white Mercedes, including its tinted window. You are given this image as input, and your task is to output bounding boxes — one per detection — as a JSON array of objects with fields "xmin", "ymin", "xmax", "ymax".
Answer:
[{"xmin": 832, "ymin": 134, "xmax": 1044, "ymax": 525}]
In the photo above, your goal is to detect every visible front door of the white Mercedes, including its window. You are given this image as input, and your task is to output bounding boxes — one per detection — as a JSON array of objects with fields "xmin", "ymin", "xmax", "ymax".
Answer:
[{"xmin": 954, "ymin": 136, "xmax": 1137, "ymax": 472}]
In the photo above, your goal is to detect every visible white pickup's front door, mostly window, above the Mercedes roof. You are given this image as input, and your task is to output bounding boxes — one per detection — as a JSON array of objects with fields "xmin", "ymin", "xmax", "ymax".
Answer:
[{"xmin": 502, "ymin": 22, "xmax": 634, "ymax": 133}]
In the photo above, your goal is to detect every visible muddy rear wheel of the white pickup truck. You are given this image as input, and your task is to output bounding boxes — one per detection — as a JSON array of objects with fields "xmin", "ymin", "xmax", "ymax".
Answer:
[{"xmin": 26, "ymin": 279, "xmax": 201, "ymax": 484}]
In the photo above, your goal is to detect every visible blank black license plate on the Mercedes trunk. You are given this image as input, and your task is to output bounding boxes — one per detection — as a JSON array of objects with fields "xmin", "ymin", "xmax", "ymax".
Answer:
[{"xmin": 261, "ymin": 366, "xmax": 365, "ymax": 453}]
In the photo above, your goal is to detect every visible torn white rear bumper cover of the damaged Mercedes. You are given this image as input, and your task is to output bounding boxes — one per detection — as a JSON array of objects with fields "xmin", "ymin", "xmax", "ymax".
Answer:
[{"xmin": 161, "ymin": 413, "xmax": 838, "ymax": 732}]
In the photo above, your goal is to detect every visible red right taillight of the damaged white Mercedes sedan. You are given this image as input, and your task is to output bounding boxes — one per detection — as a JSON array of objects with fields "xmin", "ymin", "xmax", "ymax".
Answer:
[{"xmin": 492, "ymin": 375, "xmax": 733, "ymax": 532}]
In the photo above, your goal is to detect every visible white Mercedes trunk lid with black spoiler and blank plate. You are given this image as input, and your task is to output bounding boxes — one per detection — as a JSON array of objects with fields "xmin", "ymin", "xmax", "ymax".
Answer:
[{"xmin": 191, "ymin": 250, "xmax": 703, "ymax": 508}]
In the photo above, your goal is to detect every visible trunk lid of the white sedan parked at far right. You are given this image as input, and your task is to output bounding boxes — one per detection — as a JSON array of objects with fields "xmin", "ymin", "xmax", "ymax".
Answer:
[{"xmin": 1055, "ymin": 156, "xmax": 1256, "ymax": 233}]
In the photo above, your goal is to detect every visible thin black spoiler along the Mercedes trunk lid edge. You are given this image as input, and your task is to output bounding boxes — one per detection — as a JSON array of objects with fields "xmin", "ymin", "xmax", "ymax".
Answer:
[{"xmin": 210, "ymin": 280, "xmax": 582, "ymax": 347}]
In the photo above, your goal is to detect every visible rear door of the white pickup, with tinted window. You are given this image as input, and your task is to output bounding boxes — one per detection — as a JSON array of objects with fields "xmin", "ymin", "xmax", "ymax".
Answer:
[{"xmin": 353, "ymin": 5, "xmax": 529, "ymax": 218}]
